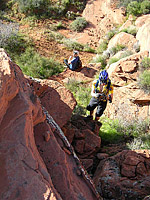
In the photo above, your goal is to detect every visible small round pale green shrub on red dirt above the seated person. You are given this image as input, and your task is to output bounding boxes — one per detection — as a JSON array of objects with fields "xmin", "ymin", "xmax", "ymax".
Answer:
[{"xmin": 70, "ymin": 17, "xmax": 88, "ymax": 32}]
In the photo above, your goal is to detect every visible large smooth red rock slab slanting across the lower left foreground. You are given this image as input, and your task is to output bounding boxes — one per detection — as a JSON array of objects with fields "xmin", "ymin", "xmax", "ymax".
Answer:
[{"xmin": 0, "ymin": 49, "xmax": 99, "ymax": 200}]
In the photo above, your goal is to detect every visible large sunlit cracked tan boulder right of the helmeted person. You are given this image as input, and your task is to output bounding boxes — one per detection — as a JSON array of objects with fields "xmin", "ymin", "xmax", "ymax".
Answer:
[{"xmin": 105, "ymin": 51, "xmax": 150, "ymax": 121}]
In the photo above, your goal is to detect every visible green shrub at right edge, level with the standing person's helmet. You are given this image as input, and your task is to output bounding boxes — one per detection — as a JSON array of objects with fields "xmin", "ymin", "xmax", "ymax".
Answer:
[{"xmin": 139, "ymin": 70, "xmax": 150, "ymax": 93}]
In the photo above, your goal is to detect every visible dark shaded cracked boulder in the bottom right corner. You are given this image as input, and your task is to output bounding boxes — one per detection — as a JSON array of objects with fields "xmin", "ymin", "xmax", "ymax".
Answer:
[{"xmin": 94, "ymin": 150, "xmax": 150, "ymax": 200}]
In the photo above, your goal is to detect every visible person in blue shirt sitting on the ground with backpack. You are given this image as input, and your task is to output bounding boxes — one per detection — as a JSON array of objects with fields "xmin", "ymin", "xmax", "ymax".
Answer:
[{"xmin": 64, "ymin": 51, "xmax": 82, "ymax": 71}]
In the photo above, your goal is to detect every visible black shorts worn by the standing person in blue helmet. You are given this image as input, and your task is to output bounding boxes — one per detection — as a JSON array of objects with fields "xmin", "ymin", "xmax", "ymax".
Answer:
[{"xmin": 86, "ymin": 97, "xmax": 107, "ymax": 117}]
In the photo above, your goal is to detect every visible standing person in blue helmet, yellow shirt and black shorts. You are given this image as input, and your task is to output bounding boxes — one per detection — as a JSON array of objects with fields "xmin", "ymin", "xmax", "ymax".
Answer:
[{"xmin": 87, "ymin": 70, "xmax": 113, "ymax": 121}]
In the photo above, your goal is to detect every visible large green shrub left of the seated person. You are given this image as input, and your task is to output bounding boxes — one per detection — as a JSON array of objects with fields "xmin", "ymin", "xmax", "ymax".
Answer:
[{"xmin": 15, "ymin": 47, "xmax": 63, "ymax": 79}]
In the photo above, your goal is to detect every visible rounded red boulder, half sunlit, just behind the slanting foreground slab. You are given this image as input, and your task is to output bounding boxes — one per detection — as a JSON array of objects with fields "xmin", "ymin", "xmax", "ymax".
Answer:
[{"xmin": 29, "ymin": 79, "xmax": 76, "ymax": 127}]
